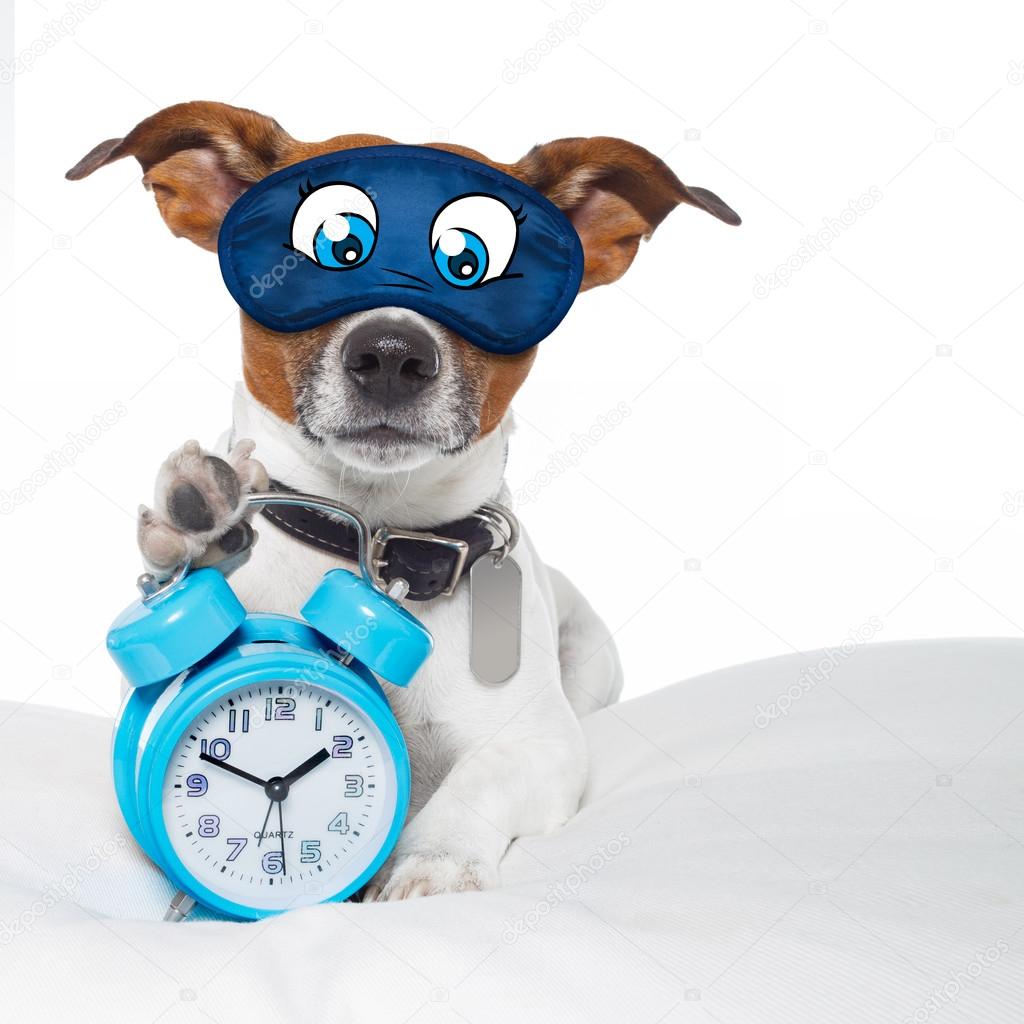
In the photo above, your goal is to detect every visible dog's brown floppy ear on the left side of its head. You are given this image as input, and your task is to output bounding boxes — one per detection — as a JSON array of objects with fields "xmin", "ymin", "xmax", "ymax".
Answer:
[{"xmin": 66, "ymin": 100, "xmax": 297, "ymax": 251}]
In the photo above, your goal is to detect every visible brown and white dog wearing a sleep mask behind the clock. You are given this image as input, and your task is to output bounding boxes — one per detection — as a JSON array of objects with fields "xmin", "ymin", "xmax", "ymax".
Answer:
[{"xmin": 68, "ymin": 101, "xmax": 739, "ymax": 901}]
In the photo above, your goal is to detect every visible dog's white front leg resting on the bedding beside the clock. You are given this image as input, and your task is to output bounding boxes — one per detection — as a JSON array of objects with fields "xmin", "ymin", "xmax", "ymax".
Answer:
[{"xmin": 362, "ymin": 716, "xmax": 586, "ymax": 902}]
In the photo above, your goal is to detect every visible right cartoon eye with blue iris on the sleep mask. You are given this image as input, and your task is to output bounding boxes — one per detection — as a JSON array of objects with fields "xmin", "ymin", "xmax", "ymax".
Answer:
[{"xmin": 430, "ymin": 196, "xmax": 519, "ymax": 288}]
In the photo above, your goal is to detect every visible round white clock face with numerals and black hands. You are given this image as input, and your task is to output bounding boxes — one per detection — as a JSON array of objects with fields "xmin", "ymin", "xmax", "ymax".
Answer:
[{"xmin": 163, "ymin": 682, "xmax": 396, "ymax": 910}]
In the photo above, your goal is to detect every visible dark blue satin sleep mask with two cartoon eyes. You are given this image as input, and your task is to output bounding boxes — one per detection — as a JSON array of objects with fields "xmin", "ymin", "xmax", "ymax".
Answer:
[{"xmin": 217, "ymin": 145, "xmax": 583, "ymax": 354}]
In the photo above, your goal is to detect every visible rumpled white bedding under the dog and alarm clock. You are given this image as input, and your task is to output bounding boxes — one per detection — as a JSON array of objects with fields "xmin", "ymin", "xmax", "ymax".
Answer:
[{"xmin": 0, "ymin": 640, "xmax": 1024, "ymax": 1024}]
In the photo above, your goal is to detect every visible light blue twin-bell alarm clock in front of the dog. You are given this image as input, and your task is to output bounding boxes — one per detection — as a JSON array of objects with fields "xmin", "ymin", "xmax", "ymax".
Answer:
[{"xmin": 106, "ymin": 493, "xmax": 432, "ymax": 920}]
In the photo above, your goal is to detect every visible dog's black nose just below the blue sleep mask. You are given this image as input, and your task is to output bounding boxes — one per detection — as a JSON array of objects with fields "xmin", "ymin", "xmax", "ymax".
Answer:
[{"xmin": 341, "ymin": 319, "xmax": 440, "ymax": 404}]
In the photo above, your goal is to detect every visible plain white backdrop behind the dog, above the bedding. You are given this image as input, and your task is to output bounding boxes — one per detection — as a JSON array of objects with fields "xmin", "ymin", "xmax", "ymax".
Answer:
[{"xmin": 0, "ymin": 0, "xmax": 1024, "ymax": 713}]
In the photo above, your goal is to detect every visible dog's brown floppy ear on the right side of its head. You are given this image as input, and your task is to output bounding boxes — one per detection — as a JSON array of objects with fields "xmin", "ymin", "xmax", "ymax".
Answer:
[{"xmin": 511, "ymin": 137, "xmax": 739, "ymax": 291}]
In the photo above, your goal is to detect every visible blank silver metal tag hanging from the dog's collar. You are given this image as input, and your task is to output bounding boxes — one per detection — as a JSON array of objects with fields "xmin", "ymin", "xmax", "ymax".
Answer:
[{"xmin": 469, "ymin": 556, "xmax": 522, "ymax": 683}]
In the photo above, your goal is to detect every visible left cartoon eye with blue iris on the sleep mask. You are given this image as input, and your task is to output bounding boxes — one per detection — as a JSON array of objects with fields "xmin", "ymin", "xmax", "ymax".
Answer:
[{"xmin": 292, "ymin": 184, "xmax": 377, "ymax": 270}]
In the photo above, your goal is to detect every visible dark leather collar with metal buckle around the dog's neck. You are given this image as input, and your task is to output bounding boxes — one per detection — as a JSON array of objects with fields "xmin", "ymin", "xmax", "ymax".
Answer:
[{"xmin": 260, "ymin": 480, "xmax": 496, "ymax": 601}]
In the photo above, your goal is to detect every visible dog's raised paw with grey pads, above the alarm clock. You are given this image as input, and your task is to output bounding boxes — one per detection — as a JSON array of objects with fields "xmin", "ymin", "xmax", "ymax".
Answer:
[{"xmin": 138, "ymin": 440, "xmax": 269, "ymax": 577}]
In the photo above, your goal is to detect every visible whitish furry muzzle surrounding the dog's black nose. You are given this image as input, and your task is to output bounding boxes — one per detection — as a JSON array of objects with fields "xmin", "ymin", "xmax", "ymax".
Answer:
[{"xmin": 295, "ymin": 306, "xmax": 482, "ymax": 472}]
